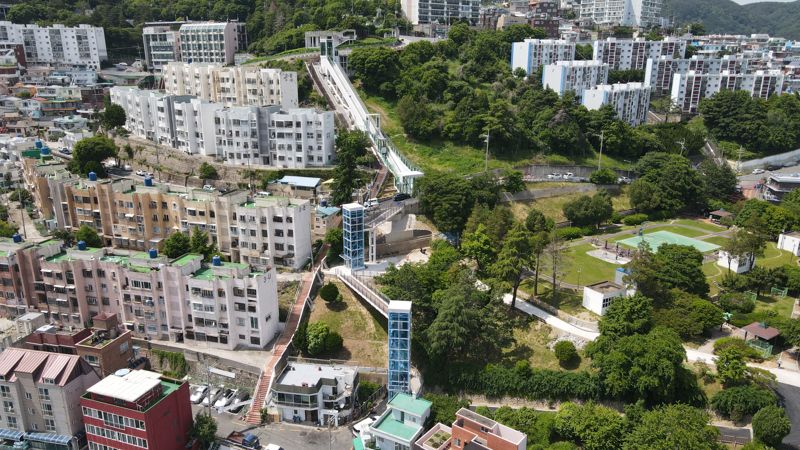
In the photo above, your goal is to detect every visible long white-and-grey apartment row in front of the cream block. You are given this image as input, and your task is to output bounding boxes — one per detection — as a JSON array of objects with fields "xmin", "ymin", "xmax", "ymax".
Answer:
[{"xmin": 110, "ymin": 87, "xmax": 335, "ymax": 168}]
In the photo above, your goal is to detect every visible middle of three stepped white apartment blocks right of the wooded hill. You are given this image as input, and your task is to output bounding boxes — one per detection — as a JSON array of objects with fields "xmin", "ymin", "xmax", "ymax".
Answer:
[{"xmin": 542, "ymin": 61, "xmax": 608, "ymax": 97}]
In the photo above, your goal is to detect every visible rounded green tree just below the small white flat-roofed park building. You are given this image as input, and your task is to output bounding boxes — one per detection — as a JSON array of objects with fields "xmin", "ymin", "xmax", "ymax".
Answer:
[{"xmin": 600, "ymin": 293, "xmax": 653, "ymax": 338}]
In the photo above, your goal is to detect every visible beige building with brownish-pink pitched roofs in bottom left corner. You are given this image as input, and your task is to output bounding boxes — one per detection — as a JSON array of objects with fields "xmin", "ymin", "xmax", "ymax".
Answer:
[{"xmin": 0, "ymin": 348, "xmax": 100, "ymax": 450}]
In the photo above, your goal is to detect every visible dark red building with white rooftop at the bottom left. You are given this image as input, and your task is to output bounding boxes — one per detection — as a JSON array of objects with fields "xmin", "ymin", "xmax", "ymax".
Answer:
[{"xmin": 80, "ymin": 370, "xmax": 192, "ymax": 450}]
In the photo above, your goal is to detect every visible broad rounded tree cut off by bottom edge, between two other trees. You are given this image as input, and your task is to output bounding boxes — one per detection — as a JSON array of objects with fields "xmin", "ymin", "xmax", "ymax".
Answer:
[{"xmin": 622, "ymin": 405, "xmax": 726, "ymax": 450}]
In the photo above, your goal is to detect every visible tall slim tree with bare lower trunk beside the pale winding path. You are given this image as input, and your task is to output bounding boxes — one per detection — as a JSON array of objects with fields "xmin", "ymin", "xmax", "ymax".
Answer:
[{"xmin": 490, "ymin": 224, "xmax": 533, "ymax": 309}]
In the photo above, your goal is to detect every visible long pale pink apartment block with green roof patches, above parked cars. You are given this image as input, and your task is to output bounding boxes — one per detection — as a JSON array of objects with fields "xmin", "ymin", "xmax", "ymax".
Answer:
[{"xmin": 41, "ymin": 244, "xmax": 278, "ymax": 350}]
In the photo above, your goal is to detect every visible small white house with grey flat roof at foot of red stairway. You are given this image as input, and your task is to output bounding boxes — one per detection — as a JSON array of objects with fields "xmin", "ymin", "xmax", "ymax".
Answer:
[{"xmin": 269, "ymin": 362, "xmax": 358, "ymax": 426}]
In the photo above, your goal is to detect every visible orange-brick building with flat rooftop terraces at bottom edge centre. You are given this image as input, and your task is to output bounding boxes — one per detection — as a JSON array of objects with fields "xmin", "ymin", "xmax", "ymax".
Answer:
[{"xmin": 416, "ymin": 408, "xmax": 528, "ymax": 450}]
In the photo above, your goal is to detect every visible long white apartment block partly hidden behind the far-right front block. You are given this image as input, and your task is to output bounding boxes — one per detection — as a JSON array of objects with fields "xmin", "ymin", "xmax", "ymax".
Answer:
[{"xmin": 644, "ymin": 55, "xmax": 751, "ymax": 97}]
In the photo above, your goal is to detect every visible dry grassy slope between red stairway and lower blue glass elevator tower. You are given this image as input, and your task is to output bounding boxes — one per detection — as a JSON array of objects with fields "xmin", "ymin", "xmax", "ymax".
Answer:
[{"xmin": 309, "ymin": 281, "xmax": 387, "ymax": 367}]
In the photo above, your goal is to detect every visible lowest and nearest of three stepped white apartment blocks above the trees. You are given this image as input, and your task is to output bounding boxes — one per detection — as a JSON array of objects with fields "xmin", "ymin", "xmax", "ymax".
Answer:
[{"xmin": 583, "ymin": 83, "xmax": 650, "ymax": 126}]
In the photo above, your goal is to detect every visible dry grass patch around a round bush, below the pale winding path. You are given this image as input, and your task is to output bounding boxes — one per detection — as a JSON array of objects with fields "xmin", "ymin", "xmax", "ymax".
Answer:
[{"xmin": 503, "ymin": 317, "xmax": 591, "ymax": 371}]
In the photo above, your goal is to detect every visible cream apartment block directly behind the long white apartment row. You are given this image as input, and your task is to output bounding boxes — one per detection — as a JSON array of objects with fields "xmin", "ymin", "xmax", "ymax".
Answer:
[{"xmin": 163, "ymin": 62, "xmax": 298, "ymax": 109}]
